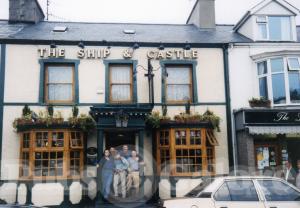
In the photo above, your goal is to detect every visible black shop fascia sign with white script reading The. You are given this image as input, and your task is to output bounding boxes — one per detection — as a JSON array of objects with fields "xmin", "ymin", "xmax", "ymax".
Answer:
[{"xmin": 245, "ymin": 110, "xmax": 300, "ymax": 125}]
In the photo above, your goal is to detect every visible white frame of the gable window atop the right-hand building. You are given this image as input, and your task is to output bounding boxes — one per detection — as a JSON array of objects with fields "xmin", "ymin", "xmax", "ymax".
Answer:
[{"xmin": 255, "ymin": 15, "xmax": 294, "ymax": 42}]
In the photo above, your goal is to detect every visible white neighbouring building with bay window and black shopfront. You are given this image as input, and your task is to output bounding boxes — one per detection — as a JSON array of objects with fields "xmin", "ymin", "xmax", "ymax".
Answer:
[{"xmin": 229, "ymin": 0, "xmax": 300, "ymax": 175}]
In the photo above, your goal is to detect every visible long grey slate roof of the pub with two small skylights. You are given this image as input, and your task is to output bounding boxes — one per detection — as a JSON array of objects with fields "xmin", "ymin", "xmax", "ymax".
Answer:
[{"xmin": 0, "ymin": 20, "xmax": 252, "ymax": 44}]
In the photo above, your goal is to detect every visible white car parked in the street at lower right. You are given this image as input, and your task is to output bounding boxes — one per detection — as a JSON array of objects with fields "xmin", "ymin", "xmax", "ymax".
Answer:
[{"xmin": 159, "ymin": 177, "xmax": 300, "ymax": 208}]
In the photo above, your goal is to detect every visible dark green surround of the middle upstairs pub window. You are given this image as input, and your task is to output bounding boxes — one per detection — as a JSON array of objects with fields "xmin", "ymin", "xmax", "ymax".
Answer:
[{"xmin": 103, "ymin": 59, "xmax": 137, "ymax": 103}]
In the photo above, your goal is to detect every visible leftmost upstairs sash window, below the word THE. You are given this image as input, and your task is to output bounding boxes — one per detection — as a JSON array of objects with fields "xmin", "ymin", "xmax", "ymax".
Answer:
[{"xmin": 44, "ymin": 64, "xmax": 75, "ymax": 103}]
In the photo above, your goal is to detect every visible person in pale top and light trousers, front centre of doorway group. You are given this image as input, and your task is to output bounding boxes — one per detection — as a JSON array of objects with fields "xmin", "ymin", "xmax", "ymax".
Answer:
[{"xmin": 113, "ymin": 153, "xmax": 129, "ymax": 198}]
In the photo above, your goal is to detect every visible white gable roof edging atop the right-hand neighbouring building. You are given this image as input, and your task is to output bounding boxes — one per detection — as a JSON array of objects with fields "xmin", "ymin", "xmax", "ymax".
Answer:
[{"xmin": 233, "ymin": 0, "xmax": 300, "ymax": 31}]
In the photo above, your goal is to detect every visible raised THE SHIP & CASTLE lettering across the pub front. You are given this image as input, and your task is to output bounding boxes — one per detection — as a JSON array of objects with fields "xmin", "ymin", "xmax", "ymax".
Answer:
[{"xmin": 38, "ymin": 48, "xmax": 198, "ymax": 60}]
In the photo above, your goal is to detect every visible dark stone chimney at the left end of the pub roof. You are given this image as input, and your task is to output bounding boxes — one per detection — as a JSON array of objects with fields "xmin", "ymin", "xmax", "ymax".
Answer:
[{"xmin": 9, "ymin": 0, "xmax": 45, "ymax": 23}]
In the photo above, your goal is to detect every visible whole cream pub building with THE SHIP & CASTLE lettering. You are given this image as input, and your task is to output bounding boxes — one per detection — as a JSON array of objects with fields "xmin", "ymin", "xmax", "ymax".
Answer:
[{"xmin": 0, "ymin": 0, "xmax": 240, "ymax": 207}]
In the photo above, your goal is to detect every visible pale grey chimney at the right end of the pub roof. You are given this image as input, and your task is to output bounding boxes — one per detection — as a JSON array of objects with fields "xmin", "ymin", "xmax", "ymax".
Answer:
[{"xmin": 187, "ymin": 0, "xmax": 216, "ymax": 29}]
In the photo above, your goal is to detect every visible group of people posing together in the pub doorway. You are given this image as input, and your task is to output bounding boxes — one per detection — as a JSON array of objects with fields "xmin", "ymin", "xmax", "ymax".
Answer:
[{"xmin": 98, "ymin": 145, "xmax": 145, "ymax": 200}]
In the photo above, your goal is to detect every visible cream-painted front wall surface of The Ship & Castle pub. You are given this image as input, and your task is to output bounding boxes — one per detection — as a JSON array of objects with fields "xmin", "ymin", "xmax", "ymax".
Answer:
[{"xmin": 1, "ymin": 45, "xmax": 229, "ymax": 205}]
